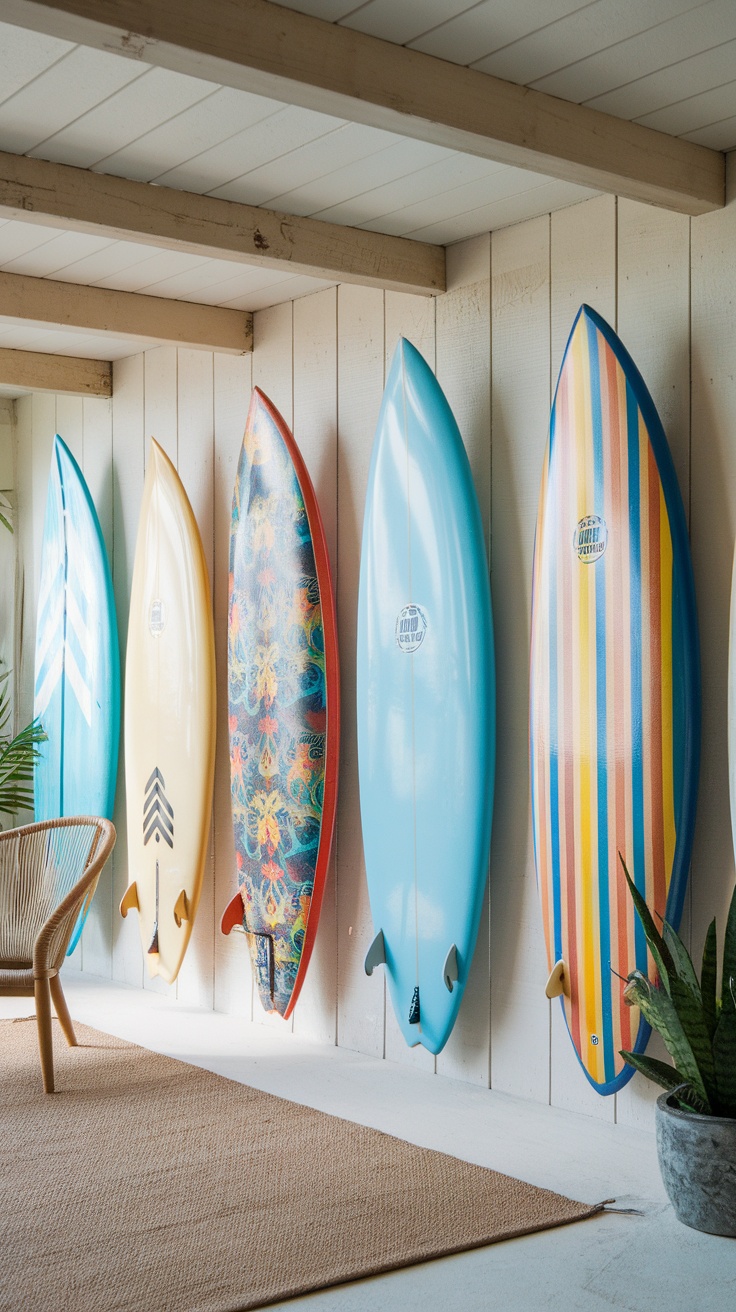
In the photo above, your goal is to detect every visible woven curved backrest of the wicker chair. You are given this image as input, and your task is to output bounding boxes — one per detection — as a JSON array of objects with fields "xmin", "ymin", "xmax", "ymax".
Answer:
[{"xmin": 0, "ymin": 816, "xmax": 114, "ymax": 963}]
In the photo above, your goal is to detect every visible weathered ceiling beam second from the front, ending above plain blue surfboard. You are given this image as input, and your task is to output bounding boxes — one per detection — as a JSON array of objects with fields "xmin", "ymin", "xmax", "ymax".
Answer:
[{"xmin": 0, "ymin": 152, "xmax": 445, "ymax": 295}]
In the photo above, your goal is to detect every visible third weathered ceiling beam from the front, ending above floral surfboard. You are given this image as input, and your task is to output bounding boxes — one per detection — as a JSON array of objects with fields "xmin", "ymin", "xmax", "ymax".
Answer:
[{"xmin": 0, "ymin": 273, "xmax": 253, "ymax": 356}]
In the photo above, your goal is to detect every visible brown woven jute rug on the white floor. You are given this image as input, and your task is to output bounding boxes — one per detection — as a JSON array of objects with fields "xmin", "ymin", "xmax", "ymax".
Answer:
[{"xmin": 0, "ymin": 1019, "xmax": 601, "ymax": 1312}]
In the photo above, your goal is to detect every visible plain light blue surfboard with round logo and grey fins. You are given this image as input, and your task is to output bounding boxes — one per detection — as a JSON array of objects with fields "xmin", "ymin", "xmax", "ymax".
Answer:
[{"xmin": 357, "ymin": 338, "xmax": 496, "ymax": 1052}]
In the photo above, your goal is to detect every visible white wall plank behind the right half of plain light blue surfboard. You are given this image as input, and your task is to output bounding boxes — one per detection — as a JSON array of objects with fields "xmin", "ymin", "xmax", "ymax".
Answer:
[{"xmin": 436, "ymin": 234, "xmax": 491, "ymax": 1086}]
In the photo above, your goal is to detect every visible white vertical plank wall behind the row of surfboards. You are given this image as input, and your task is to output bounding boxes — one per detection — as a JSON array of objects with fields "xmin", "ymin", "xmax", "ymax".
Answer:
[{"xmin": 17, "ymin": 182, "xmax": 736, "ymax": 1124}]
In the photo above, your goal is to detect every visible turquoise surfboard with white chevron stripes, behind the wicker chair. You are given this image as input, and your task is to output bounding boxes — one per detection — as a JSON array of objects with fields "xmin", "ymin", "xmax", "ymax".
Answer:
[{"xmin": 33, "ymin": 434, "xmax": 121, "ymax": 953}]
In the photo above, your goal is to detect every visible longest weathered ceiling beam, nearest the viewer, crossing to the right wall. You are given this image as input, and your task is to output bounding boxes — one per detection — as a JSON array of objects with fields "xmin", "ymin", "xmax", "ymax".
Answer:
[{"xmin": 3, "ymin": 0, "xmax": 726, "ymax": 214}]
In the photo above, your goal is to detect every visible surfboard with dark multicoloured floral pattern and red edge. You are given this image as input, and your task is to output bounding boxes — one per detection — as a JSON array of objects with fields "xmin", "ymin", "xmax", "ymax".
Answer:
[{"xmin": 222, "ymin": 387, "xmax": 340, "ymax": 1018}]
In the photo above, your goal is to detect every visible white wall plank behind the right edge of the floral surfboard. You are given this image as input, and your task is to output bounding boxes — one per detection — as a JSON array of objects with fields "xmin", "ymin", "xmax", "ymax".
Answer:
[{"xmin": 294, "ymin": 287, "xmax": 337, "ymax": 1043}]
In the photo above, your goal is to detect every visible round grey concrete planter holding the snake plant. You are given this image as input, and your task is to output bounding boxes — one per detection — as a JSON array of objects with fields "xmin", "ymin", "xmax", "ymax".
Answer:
[{"xmin": 656, "ymin": 1093, "xmax": 736, "ymax": 1237}]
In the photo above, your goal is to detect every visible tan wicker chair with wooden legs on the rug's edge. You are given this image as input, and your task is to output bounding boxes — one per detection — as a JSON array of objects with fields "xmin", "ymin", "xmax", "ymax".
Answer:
[{"xmin": 0, "ymin": 816, "xmax": 115, "ymax": 1093}]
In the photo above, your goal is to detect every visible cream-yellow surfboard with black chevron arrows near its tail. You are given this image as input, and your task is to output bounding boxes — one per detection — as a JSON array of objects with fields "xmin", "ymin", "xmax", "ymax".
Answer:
[{"xmin": 121, "ymin": 441, "xmax": 215, "ymax": 984}]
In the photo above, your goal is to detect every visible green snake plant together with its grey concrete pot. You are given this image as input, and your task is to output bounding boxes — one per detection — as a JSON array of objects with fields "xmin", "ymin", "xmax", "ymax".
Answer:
[{"xmin": 621, "ymin": 857, "xmax": 736, "ymax": 1236}]
